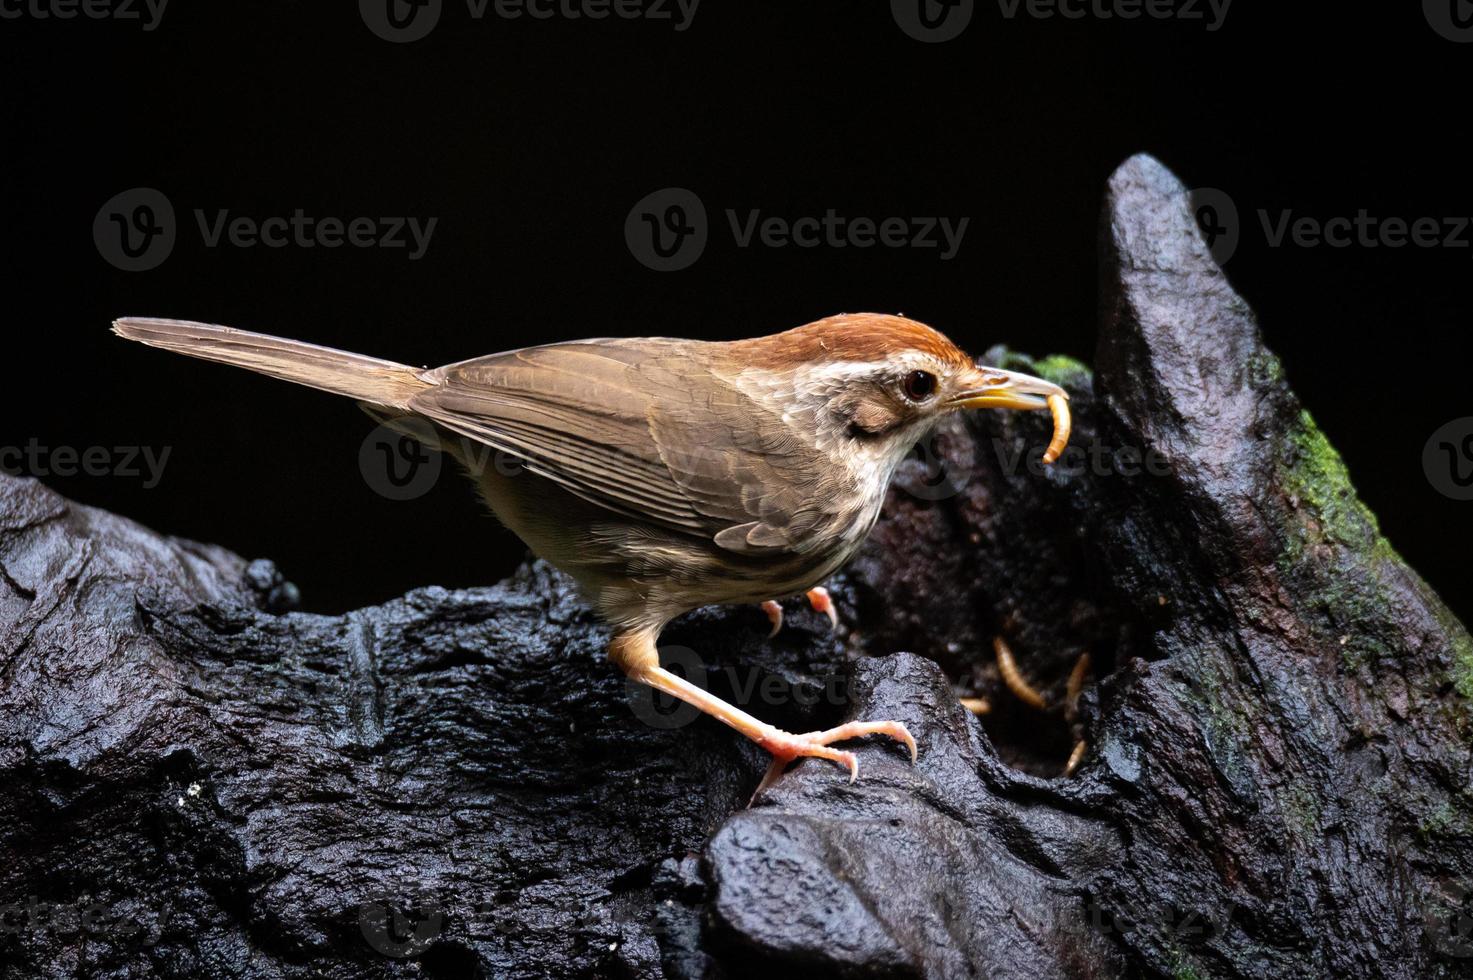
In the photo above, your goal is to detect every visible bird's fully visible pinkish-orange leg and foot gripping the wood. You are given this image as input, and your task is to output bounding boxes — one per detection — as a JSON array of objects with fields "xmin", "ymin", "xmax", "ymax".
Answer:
[{"xmin": 608, "ymin": 629, "xmax": 916, "ymax": 793}]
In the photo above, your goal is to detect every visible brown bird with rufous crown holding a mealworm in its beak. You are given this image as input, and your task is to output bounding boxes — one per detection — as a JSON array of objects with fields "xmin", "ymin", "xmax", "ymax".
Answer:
[{"xmin": 113, "ymin": 314, "xmax": 1069, "ymax": 791}]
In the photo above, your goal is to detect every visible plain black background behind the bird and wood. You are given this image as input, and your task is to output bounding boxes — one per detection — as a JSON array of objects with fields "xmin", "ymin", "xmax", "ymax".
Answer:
[{"xmin": 0, "ymin": 0, "xmax": 1473, "ymax": 619}]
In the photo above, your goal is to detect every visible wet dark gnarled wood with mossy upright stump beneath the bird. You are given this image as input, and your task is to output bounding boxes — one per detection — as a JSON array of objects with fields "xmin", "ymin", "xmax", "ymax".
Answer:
[{"xmin": 0, "ymin": 158, "xmax": 1473, "ymax": 979}]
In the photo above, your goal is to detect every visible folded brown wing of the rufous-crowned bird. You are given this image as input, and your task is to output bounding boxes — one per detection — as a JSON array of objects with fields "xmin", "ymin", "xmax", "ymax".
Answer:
[{"xmin": 409, "ymin": 339, "xmax": 831, "ymax": 554}]
